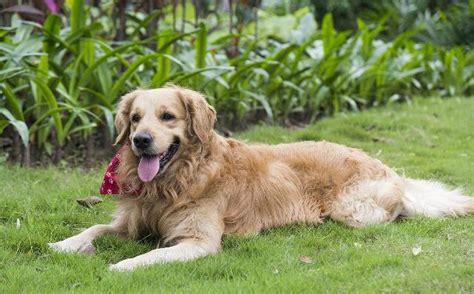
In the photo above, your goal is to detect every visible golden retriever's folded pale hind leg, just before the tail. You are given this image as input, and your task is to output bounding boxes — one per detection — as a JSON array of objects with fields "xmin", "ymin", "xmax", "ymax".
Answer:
[{"xmin": 329, "ymin": 179, "xmax": 403, "ymax": 227}]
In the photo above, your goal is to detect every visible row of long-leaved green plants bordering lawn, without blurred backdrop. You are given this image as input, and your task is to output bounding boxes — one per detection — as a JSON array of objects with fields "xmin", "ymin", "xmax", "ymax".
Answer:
[{"xmin": 0, "ymin": 1, "xmax": 474, "ymax": 163}]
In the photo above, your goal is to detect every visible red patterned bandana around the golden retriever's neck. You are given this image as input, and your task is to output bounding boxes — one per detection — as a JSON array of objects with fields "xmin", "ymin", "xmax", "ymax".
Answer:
[{"xmin": 100, "ymin": 145, "xmax": 141, "ymax": 196}]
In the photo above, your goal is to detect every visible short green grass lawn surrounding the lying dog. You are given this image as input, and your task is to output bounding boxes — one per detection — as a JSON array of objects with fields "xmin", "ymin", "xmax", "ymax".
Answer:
[{"xmin": 0, "ymin": 99, "xmax": 474, "ymax": 293}]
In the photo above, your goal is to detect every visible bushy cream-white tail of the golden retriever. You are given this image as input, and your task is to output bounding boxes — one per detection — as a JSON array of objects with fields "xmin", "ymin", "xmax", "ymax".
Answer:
[{"xmin": 401, "ymin": 179, "xmax": 474, "ymax": 218}]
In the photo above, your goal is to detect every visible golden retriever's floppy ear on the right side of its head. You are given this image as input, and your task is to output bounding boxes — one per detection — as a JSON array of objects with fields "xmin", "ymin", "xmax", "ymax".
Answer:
[{"xmin": 178, "ymin": 89, "xmax": 216, "ymax": 143}]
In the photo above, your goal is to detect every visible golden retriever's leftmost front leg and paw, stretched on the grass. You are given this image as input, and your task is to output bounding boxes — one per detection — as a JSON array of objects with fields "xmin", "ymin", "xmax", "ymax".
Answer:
[{"xmin": 48, "ymin": 224, "xmax": 120, "ymax": 255}]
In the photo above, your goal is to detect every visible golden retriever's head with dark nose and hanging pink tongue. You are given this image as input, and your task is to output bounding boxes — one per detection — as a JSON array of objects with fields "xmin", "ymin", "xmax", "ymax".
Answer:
[{"xmin": 115, "ymin": 87, "xmax": 216, "ymax": 182}]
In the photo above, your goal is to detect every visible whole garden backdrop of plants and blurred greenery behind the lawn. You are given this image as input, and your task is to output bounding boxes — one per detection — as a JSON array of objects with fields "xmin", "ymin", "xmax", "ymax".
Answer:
[{"xmin": 0, "ymin": 0, "xmax": 474, "ymax": 165}]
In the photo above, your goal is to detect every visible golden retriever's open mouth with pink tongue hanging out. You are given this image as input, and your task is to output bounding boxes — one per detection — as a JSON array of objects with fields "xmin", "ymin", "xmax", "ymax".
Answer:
[{"xmin": 138, "ymin": 140, "xmax": 179, "ymax": 182}]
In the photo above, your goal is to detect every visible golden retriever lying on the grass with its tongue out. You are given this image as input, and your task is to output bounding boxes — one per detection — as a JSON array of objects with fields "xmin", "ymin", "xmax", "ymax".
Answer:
[{"xmin": 50, "ymin": 86, "xmax": 474, "ymax": 271}]
